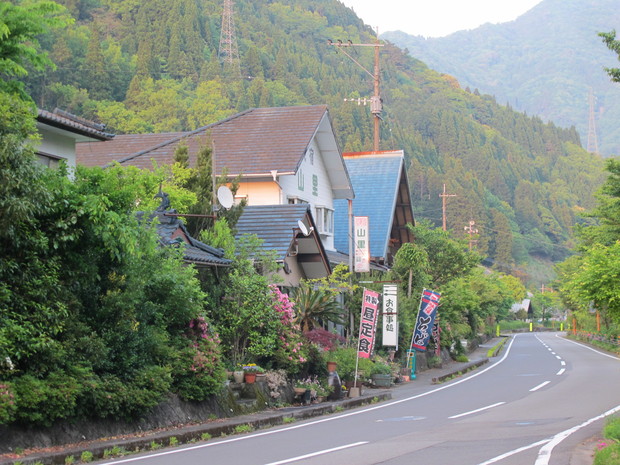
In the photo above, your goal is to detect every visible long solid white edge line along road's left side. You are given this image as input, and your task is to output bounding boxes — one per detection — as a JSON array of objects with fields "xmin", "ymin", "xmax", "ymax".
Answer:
[{"xmin": 101, "ymin": 334, "xmax": 519, "ymax": 465}]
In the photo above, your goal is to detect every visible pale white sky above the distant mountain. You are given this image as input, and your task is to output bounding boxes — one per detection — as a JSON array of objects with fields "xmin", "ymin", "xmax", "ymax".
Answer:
[{"xmin": 342, "ymin": 0, "xmax": 542, "ymax": 37}]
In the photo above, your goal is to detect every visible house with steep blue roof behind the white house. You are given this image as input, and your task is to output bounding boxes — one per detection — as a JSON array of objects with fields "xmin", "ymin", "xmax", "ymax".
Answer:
[{"xmin": 328, "ymin": 150, "xmax": 415, "ymax": 269}]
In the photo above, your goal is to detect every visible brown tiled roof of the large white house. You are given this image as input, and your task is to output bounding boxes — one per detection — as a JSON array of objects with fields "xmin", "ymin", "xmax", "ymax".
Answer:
[{"xmin": 77, "ymin": 105, "xmax": 331, "ymax": 176}]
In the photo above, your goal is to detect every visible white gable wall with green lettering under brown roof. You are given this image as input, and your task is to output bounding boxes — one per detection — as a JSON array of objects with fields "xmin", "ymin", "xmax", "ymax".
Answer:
[{"xmin": 278, "ymin": 140, "xmax": 334, "ymax": 250}]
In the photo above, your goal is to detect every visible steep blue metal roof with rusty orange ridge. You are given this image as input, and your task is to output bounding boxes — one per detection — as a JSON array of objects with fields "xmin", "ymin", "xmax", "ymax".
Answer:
[{"xmin": 334, "ymin": 151, "xmax": 403, "ymax": 258}]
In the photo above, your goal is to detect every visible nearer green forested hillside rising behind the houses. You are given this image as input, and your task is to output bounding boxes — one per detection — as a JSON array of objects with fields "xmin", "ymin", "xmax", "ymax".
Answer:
[{"xmin": 21, "ymin": 0, "xmax": 604, "ymax": 283}]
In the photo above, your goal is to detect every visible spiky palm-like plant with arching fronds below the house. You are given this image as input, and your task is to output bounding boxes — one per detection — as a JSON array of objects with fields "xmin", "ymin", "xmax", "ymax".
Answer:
[{"xmin": 292, "ymin": 284, "xmax": 342, "ymax": 332}]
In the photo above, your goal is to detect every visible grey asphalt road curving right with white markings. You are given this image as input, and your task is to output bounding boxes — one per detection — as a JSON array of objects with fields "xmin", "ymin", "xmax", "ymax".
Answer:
[{"xmin": 93, "ymin": 333, "xmax": 620, "ymax": 465}]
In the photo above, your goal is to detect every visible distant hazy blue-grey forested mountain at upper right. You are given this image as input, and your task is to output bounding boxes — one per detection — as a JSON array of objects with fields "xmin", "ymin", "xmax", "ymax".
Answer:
[{"xmin": 382, "ymin": 0, "xmax": 620, "ymax": 156}]
